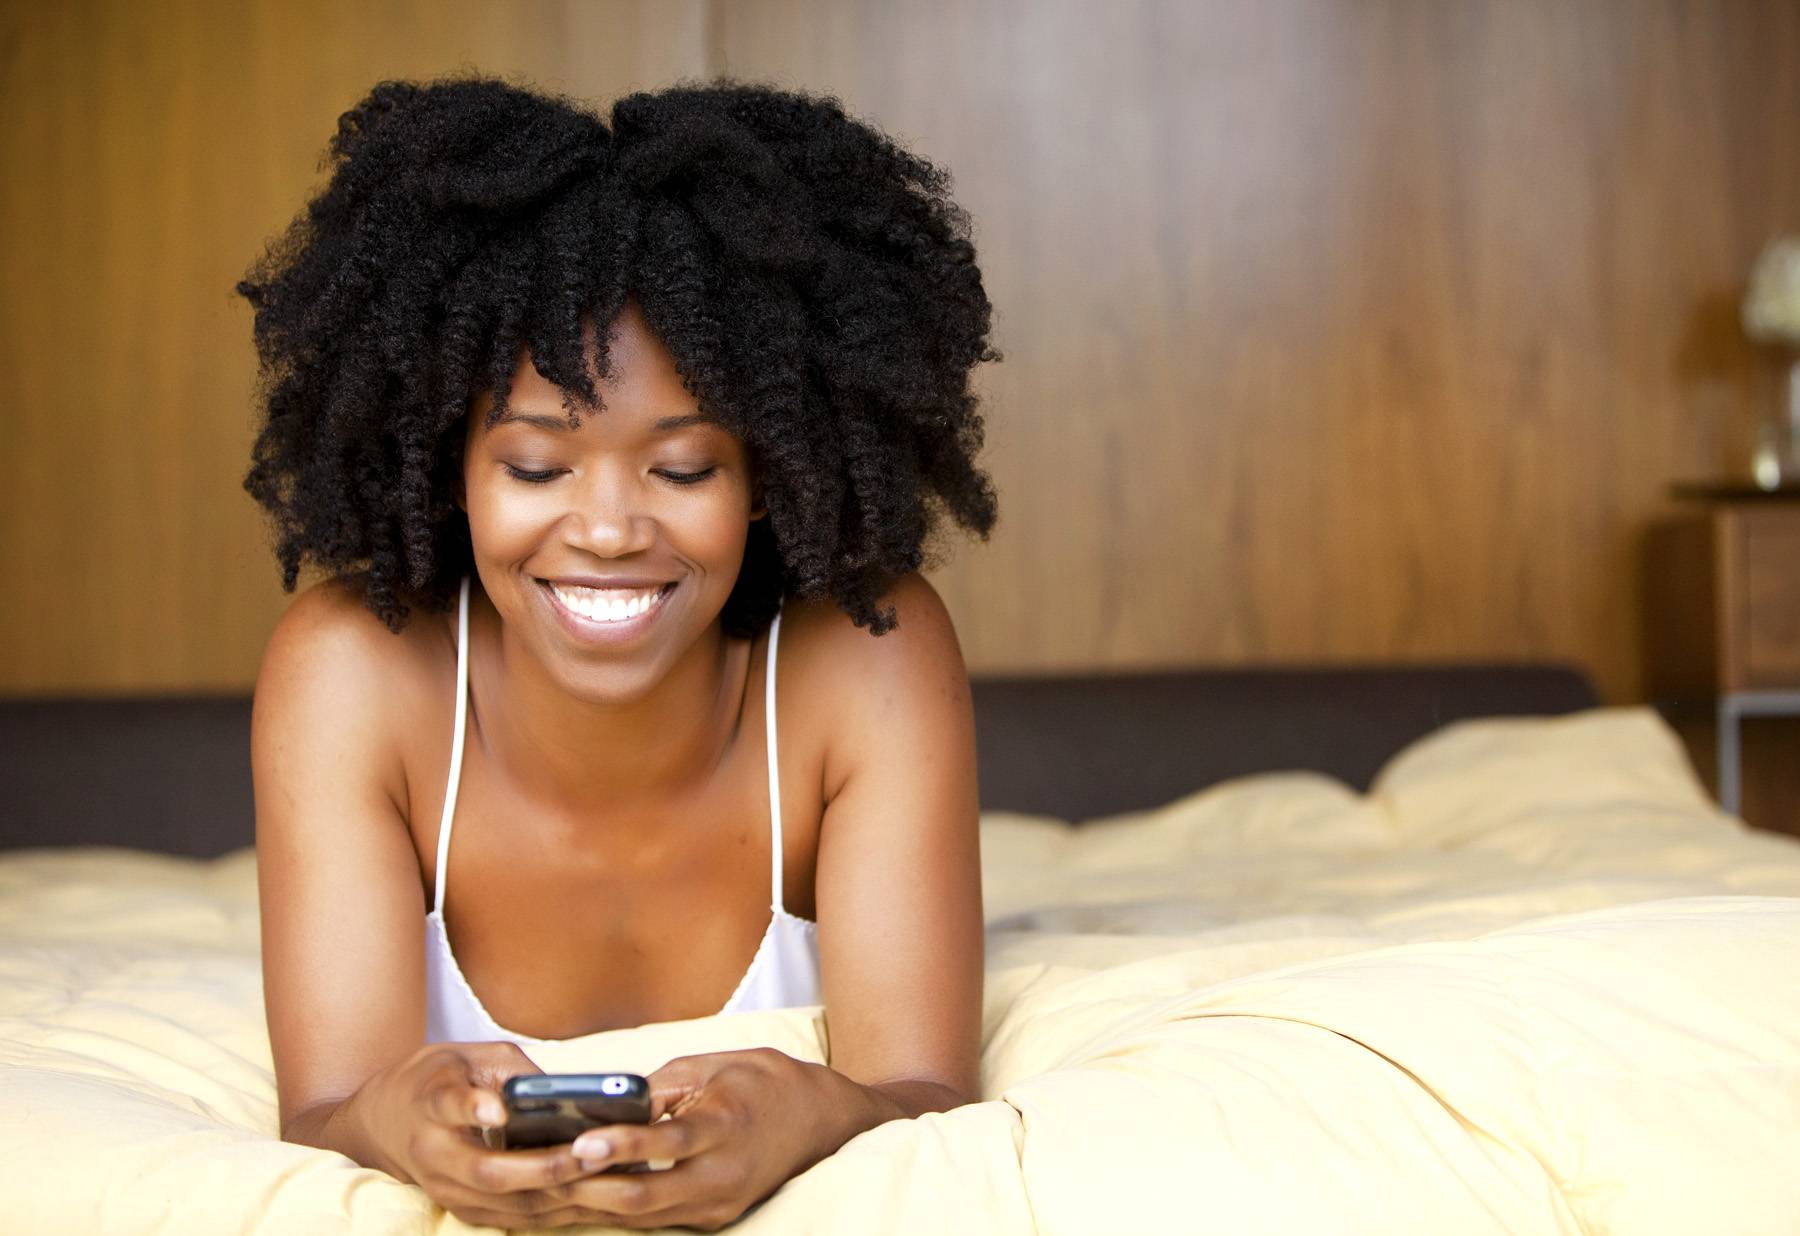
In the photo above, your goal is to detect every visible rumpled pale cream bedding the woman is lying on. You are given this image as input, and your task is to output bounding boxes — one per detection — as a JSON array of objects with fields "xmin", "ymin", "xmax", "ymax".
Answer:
[{"xmin": 0, "ymin": 709, "xmax": 1800, "ymax": 1236}]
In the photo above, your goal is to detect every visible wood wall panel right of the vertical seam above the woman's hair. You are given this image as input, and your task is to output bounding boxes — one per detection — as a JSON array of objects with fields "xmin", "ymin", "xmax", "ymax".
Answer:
[{"xmin": 718, "ymin": 0, "xmax": 1800, "ymax": 700}]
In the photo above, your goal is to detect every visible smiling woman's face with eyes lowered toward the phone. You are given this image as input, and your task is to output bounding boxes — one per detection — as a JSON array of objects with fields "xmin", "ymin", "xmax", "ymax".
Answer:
[{"xmin": 463, "ymin": 300, "xmax": 760, "ymax": 702}]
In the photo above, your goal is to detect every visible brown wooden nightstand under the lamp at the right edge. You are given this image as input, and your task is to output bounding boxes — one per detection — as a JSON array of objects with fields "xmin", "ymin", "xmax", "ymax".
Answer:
[{"xmin": 1643, "ymin": 486, "xmax": 1800, "ymax": 831}]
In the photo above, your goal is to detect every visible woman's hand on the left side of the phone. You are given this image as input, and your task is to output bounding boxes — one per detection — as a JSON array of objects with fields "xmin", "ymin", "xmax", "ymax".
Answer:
[{"xmin": 346, "ymin": 1042, "xmax": 612, "ymax": 1227}]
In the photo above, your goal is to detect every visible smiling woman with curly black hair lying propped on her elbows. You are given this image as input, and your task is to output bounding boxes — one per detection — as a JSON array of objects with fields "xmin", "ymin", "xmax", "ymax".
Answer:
[{"xmin": 239, "ymin": 79, "xmax": 997, "ymax": 1227}]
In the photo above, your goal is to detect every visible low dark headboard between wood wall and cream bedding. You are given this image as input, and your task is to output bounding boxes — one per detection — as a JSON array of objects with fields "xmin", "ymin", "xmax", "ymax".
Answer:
[{"xmin": 0, "ymin": 664, "xmax": 1597, "ymax": 856}]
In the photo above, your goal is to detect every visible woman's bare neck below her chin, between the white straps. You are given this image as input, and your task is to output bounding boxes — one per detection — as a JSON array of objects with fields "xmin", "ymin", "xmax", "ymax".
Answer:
[{"xmin": 470, "ymin": 592, "xmax": 749, "ymax": 819}]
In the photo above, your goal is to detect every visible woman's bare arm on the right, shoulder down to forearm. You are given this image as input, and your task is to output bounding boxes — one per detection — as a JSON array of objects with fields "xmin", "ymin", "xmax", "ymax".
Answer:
[{"xmin": 817, "ymin": 576, "xmax": 983, "ymax": 1124}]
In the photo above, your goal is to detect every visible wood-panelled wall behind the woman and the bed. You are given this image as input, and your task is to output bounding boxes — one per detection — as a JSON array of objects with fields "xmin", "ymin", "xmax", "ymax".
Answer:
[{"xmin": 0, "ymin": 0, "xmax": 1800, "ymax": 702}]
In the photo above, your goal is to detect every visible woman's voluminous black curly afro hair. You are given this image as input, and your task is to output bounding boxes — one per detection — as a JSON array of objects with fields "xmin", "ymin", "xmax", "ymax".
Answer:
[{"xmin": 238, "ymin": 77, "xmax": 999, "ymax": 635}]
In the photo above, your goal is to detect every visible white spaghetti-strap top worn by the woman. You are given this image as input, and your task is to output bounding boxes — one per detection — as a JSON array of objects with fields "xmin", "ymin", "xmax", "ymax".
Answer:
[{"xmin": 425, "ymin": 576, "xmax": 821, "ymax": 1047}]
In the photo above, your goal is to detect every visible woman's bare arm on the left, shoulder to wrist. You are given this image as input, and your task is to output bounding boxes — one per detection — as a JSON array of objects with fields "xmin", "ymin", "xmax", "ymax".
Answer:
[{"xmin": 250, "ymin": 583, "xmax": 425, "ymax": 1162}]
